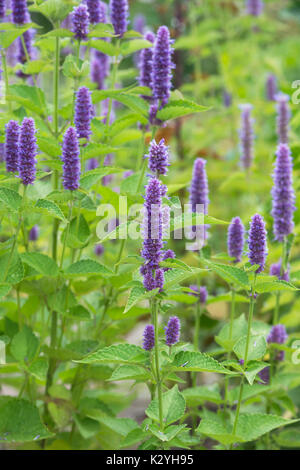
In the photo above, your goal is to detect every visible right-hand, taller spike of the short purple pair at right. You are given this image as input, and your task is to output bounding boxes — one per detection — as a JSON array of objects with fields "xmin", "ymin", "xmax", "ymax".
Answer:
[{"xmin": 247, "ymin": 214, "xmax": 267, "ymax": 273}]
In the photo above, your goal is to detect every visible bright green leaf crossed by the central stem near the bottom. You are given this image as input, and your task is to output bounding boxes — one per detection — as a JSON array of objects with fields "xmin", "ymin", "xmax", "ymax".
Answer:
[{"xmin": 146, "ymin": 385, "xmax": 185, "ymax": 426}]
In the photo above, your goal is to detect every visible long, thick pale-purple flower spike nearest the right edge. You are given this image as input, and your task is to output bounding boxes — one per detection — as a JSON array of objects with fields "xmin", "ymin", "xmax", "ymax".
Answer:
[{"xmin": 272, "ymin": 144, "xmax": 296, "ymax": 241}]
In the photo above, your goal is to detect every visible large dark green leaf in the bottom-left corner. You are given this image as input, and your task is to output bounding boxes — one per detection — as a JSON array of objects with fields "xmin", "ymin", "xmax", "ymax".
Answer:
[{"xmin": 0, "ymin": 397, "xmax": 53, "ymax": 443}]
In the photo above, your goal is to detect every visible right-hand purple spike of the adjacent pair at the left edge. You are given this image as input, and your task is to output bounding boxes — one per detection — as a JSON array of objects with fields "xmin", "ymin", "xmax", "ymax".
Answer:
[{"xmin": 19, "ymin": 118, "xmax": 37, "ymax": 186}]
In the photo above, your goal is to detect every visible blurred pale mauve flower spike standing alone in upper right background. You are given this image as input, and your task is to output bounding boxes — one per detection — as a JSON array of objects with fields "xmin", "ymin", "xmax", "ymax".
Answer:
[{"xmin": 240, "ymin": 104, "xmax": 254, "ymax": 169}]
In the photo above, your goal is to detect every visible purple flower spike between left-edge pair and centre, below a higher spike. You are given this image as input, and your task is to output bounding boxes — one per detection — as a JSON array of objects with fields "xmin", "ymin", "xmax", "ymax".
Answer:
[{"xmin": 62, "ymin": 127, "xmax": 80, "ymax": 191}]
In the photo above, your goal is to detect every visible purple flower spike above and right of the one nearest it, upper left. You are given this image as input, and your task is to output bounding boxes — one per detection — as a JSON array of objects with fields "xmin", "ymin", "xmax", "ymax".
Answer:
[{"xmin": 74, "ymin": 86, "xmax": 92, "ymax": 139}]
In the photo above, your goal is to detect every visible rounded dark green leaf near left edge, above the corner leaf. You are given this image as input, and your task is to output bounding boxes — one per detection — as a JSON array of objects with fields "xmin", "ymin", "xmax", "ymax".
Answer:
[{"xmin": 10, "ymin": 325, "xmax": 39, "ymax": 362}]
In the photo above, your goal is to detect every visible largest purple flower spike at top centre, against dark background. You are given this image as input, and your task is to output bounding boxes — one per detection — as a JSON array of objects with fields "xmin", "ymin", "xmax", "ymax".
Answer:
[{"xmin": 152, "ymin": 26, "xmax": 174, "ymax": 107}]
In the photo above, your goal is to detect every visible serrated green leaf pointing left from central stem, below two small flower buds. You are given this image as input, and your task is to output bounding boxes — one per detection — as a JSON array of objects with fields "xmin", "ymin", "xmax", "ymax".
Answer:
[{"xmin": 78, "ymin": 344, "xmax": 148, "ymax": 364}]
